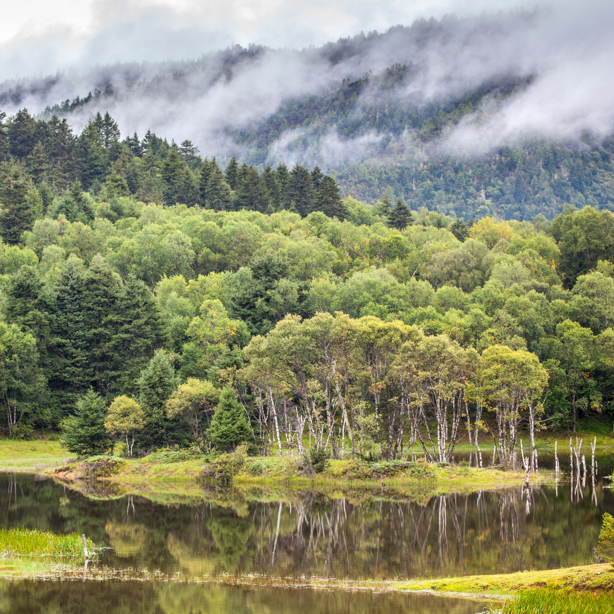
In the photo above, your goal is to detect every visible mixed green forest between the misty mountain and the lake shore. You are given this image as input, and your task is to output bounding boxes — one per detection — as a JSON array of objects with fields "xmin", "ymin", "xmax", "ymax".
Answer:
[{"xmin": 0, "ymin": 110, "xmax": 614, "ymax": 464}]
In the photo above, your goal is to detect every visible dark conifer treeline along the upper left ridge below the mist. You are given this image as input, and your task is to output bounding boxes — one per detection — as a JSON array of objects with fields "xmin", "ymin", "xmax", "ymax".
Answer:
[{"xmin": 0, "ymin": 110, "xmax": 354, "ymax": 224}]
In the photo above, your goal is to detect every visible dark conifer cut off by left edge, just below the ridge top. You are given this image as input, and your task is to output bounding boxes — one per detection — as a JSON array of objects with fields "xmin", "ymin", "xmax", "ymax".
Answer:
[{"xmin": 0, "ymin": 162, "xmax": 42, "ymax": 243}]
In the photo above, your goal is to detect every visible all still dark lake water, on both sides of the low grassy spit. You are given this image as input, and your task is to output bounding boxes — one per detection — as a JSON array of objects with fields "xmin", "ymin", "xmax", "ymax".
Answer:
[{"xmin": 0, "ymin": 450, "xmax": 614, "ymax": 614}]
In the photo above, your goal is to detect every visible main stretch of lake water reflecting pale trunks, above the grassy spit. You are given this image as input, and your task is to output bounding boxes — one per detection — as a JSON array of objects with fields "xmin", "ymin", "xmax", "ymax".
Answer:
[{"xmin": 0, "ymin": 461, "xmax": 614, "ymax": 579}]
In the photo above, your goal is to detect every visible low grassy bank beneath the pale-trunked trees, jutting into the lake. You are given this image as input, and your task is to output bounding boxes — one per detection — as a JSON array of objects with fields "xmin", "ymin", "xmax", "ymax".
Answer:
[{"xmin": 50, "ymin": 452, "xmax": 553, "ymax": 502}]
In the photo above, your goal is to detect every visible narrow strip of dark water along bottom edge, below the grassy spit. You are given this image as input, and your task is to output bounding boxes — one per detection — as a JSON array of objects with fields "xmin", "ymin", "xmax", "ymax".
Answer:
[{"xmin": 0, "ymin": 581, "xmax": 486, "ymax": 614}]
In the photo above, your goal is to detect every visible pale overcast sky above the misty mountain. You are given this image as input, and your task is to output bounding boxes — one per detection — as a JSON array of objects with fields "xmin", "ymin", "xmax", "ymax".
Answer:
[{"xmin": 0, "ymin": 0, "xmax": 544, "ymax": 80}]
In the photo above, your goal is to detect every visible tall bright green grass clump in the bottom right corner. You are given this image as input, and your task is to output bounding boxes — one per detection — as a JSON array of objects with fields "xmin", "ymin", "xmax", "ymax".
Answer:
[{"xmin": 500, "ymin": 589, "xmax": 614, "ymax": 614}]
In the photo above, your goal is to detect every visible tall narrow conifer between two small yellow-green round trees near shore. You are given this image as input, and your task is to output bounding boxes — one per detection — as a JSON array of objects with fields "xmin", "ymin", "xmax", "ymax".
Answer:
[{"xmin": 138, "ymin": 350, "xmax": 181, "ymax": 449}]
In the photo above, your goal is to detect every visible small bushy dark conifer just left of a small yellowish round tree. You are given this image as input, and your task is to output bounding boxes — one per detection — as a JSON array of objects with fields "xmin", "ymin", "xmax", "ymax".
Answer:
[{"xmin": 62, "ymin": 389, "xmax": 112, "ymax": 456}]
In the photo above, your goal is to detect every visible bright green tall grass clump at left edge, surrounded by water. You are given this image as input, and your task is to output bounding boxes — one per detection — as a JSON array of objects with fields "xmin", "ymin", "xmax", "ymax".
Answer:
[{"xmin": 0, "ymin": 529, "xmax": 96, "ymax": 563}]
